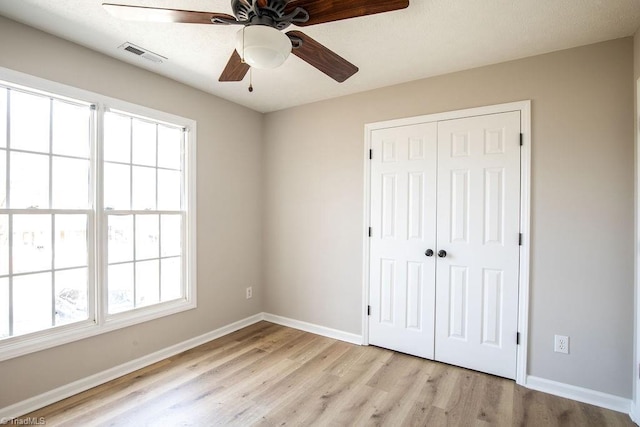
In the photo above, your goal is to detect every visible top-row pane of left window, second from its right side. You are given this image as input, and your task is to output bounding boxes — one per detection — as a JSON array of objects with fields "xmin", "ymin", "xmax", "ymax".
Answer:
[{"xmin": 9, "ymin": 90, "xmax": 50, "ymax": 153}]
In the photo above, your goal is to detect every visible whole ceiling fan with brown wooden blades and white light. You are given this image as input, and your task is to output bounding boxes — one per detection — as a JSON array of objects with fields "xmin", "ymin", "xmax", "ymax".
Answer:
[{"xmin": 102, "ymin": 0, "xmax": 409, "ymax": 85}]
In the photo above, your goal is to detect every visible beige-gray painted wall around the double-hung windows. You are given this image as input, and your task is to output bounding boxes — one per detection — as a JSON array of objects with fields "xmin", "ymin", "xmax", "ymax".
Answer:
[{"xmin": 0, "ymin": 17, "xmax": 263, "ymax": 408}]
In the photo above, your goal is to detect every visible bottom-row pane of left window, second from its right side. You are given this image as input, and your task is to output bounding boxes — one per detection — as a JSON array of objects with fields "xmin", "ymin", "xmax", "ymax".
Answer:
[{"xmin": 13, "ymin": 272, "xmax": 53, "ymax": 336}]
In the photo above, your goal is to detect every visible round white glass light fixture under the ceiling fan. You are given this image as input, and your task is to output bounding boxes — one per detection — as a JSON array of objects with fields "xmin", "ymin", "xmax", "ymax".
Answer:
[{"xmin": 236, "ymin": 25, "xmax": 291, "ymax": 68}]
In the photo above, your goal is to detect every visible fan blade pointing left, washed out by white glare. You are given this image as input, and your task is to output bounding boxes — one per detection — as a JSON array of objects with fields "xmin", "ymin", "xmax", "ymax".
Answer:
[{"xmin": 102, "ymin": 3, "xmax": 236, "ymax": 24}]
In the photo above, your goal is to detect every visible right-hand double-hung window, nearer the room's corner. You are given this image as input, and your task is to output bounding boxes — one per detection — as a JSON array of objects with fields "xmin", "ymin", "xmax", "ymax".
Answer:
[{"xmin": 103, "ymin": 112, "xmax": 185, "ymax": 314}]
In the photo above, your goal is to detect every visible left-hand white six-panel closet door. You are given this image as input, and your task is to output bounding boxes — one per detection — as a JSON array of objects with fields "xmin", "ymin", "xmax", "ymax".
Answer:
[{"xmin": 369, "ymin": 123, "xmax": 437, "ymax": 359}]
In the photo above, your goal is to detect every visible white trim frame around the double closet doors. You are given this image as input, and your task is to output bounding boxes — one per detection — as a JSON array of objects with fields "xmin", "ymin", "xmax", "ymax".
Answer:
[{"xmin": 362, "ymin": 100, "xmax": 532, "ymax": 385}]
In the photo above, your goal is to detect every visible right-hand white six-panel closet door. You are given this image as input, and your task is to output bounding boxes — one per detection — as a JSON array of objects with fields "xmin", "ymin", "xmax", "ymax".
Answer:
[{"xmin": 435, "ymin": 112, "xmax": 520, "ymax": 378}]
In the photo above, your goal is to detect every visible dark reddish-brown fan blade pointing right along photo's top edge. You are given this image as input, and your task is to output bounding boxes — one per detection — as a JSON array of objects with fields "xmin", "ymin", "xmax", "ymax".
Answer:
[{"xmin": 285, "ymin": 0, "xmax": 409, "ymax": 27}]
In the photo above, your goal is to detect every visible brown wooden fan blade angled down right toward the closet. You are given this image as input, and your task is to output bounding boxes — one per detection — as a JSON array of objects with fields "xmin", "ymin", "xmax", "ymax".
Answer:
[{"xmin": 287, "ymin": 31, "xmax": 358, "ymax": 83}]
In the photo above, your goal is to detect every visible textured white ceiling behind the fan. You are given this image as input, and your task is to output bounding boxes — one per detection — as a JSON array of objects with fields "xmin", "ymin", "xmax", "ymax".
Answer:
[{"xmin": 0, "ymin": 0, "xmax": 640, "ymax": 112}]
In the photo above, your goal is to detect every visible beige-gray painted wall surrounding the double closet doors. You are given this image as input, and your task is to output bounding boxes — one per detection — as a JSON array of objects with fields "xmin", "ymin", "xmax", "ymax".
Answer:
[{"xmin": 263, "ymin": 38, "xmax": 634, "ymax": 398}]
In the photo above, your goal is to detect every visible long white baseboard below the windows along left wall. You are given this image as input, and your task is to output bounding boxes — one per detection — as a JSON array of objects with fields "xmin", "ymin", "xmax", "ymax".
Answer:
[{"xmin": 0, "ymin": 313, "xmax": 264, "ymax": 420}]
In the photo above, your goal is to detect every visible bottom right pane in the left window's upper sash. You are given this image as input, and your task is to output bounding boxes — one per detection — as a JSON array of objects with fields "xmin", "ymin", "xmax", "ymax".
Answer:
[{"xmin": 52, "ymin": 156, "xmax": 89, "ymax": 209}]
